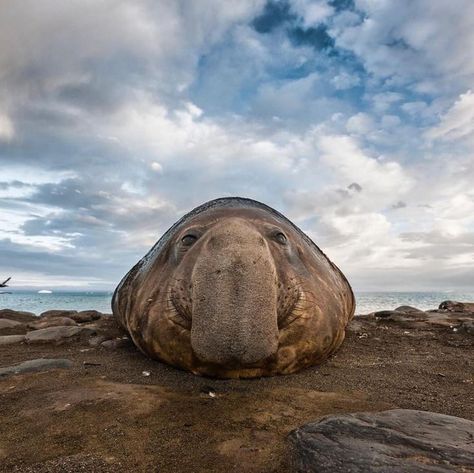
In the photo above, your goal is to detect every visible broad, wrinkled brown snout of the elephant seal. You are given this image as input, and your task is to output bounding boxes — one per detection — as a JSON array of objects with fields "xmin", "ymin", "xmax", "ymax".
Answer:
[{"xmin": 191, "ymin": 218, "xmax": 278, "ymax": 365}]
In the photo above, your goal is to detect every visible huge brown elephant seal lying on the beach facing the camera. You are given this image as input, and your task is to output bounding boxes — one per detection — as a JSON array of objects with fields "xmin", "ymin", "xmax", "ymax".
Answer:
[{"xmin": 112, "ymin": 197, "xmax": 355, "ymax": 378}]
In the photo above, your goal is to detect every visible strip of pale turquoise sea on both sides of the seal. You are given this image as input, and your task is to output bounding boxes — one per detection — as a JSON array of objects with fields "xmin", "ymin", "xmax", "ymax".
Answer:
[{"xmin": 0, "ymin": 290, "xmax": 474, "ymax": 314}]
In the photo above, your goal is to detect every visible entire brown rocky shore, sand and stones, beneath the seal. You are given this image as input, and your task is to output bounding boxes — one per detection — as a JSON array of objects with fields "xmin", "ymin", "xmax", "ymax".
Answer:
[{"xmin": 0, "ymin": 301, "xmax": 474, "ymax": 472}]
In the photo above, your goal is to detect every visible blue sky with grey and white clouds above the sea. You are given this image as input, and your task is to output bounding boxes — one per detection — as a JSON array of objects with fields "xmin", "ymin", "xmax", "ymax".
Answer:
[{"xmin": 0, "ymin": 0, "xmax": 474, "ymax": 291}]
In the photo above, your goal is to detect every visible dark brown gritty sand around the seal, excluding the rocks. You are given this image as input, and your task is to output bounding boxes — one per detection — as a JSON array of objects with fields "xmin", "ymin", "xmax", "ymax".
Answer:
[{"xmin": 0, "ymin": 319, "xmax": 474, "ymax": 473}]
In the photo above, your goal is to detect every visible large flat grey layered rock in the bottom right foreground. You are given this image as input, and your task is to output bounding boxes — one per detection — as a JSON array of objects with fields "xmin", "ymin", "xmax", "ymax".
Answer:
[{"xmin": 289, "ymin": 409, "xmax": 474, "ymax": 473}]
